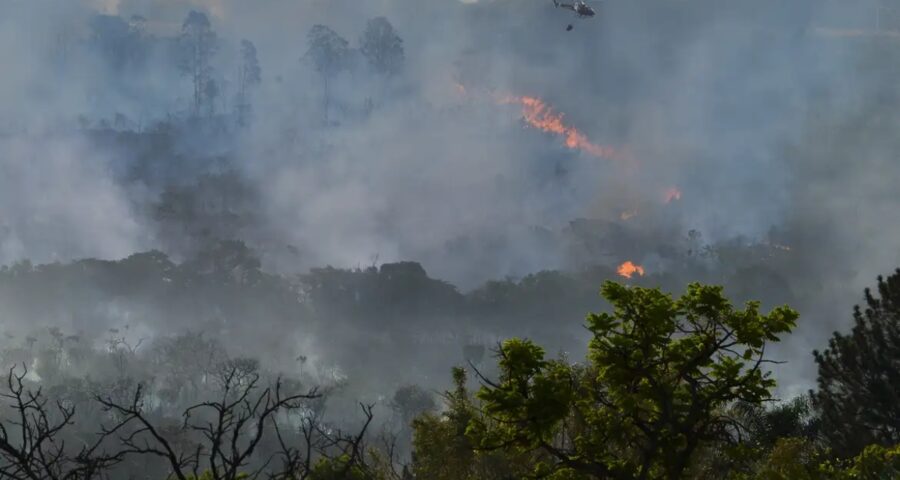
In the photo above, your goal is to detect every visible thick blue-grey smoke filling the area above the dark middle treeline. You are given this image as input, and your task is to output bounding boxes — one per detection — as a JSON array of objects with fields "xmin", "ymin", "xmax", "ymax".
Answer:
[{"xmin": 0, "ymin": 0, "xmax": 900, "ymax": 394}]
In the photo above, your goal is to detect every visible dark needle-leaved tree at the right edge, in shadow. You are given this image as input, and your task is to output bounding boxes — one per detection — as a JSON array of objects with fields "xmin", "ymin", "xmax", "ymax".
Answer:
[{"xmin": 811, "ymin": 270, "xmax": 900, "ymax": 456}]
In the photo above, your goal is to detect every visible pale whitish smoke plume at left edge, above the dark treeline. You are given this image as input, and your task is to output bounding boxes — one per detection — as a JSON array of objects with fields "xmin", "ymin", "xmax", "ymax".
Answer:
[{"xmin": 0, "ymin": 135, "xmax": 148, "ymax": 264}]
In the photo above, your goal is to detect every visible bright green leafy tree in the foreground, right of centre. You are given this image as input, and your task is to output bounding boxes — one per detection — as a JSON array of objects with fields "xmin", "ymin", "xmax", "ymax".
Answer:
[{"xmin": 468, "ymin": 282, "xmax": 797, "ymax": 479}]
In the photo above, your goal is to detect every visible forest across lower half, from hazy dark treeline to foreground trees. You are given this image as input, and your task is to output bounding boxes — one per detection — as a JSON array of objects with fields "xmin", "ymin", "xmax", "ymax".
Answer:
[{"xmin": 0, "ymin": 253, "xmax": 900, "ymax": 480}]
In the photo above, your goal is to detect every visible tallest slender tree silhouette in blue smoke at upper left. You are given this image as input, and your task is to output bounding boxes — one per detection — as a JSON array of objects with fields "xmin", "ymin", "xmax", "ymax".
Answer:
[{"xmin": 178, "ymin": 10, "xmax": 218, "ymax": 115}]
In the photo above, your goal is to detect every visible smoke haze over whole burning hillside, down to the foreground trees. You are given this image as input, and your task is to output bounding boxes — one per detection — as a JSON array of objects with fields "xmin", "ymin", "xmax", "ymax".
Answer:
[{"xmin": 0, "ymin": 0, "xmax": 900, "ymax": 478}]
